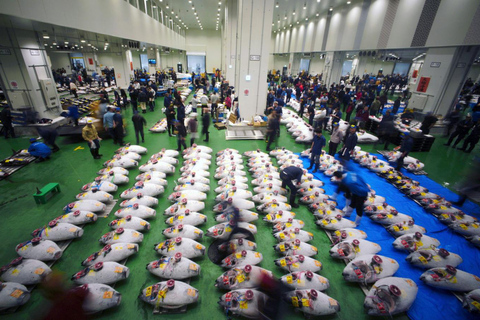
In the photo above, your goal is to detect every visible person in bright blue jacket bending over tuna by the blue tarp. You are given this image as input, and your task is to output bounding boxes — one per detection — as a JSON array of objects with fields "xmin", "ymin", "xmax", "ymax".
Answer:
[{"xmin": 330, "ymin": 171, "xmax": 370, "ymax": 226}]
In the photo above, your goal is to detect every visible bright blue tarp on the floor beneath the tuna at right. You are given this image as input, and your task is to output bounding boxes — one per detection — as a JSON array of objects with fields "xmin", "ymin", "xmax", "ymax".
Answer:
[{"xmin": 304, "ymin": 155, "xmax": 480, "ymax": 320}]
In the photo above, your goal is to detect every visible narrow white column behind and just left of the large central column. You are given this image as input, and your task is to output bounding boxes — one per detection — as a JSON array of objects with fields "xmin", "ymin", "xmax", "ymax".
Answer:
[{"xmin": 223, "ymin": 0, "xmax": 238, "ymax": 86}]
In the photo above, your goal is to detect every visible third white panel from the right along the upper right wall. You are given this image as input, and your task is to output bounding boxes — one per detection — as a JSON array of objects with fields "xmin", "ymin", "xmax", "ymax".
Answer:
[{"xmin": 360, "ymin": 0, "xmax": 388, "ymax": 49}]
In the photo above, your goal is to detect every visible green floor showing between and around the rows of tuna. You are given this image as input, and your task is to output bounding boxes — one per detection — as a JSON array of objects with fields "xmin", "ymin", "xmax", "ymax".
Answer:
[{"xmin": 0, "ymin": 94, "xmax": 472, "ymax": 319}]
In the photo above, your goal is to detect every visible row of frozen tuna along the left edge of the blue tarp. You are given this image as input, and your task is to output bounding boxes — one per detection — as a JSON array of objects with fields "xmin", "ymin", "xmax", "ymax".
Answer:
[{"xmin": 271, "ymin": 148, "xmax": 417, "ymax": 316}]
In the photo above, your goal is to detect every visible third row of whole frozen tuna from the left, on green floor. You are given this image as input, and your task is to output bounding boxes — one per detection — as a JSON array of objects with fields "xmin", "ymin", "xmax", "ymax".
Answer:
[{"xmin": 139, "ymin": 145, "xmax": 212, "ymax": 310}]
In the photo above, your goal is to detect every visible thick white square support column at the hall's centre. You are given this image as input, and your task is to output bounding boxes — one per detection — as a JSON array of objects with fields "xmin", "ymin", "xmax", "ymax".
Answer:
[{"xmin": 236, "ymin": 0, "xmax": 274, "ymax": 120}]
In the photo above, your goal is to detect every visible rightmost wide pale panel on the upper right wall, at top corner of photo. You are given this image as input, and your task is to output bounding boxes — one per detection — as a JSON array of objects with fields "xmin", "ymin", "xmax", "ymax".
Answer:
[{"xmin": 425, "ymin": 0, "xmax": 479, "ymax": 47}]
